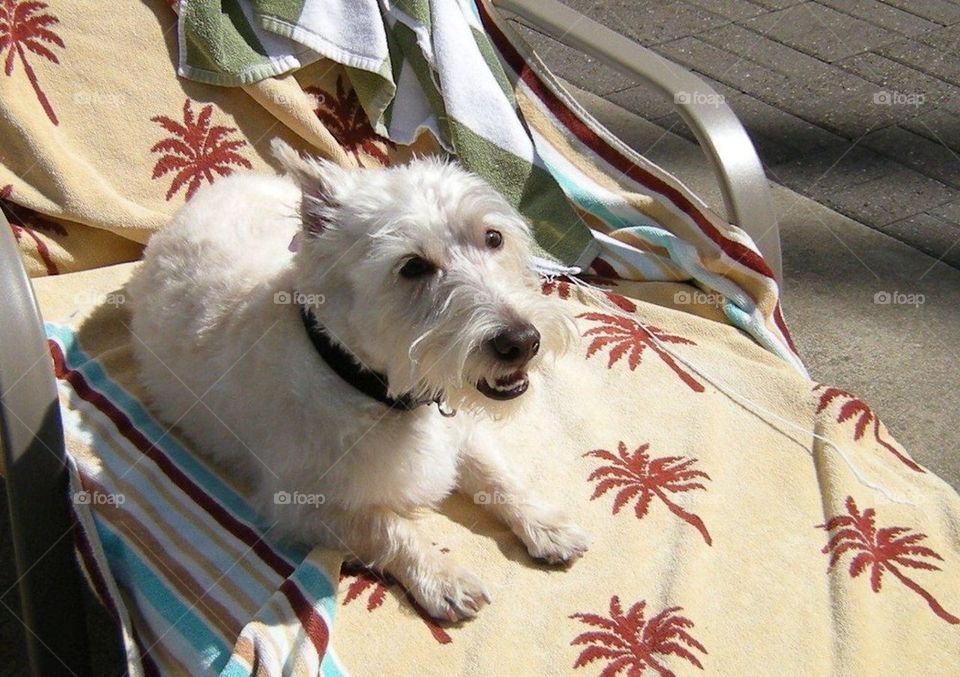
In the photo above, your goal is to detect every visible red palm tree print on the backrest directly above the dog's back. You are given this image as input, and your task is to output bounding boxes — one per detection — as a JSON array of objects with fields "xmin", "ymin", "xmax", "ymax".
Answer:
[{"xmin": 150, "ymin": 99, "xmax": 253, "ymax": 200}]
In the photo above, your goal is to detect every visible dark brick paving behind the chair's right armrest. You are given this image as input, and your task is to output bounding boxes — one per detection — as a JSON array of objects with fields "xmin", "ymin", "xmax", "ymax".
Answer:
[{"xmin": 506, "ymin": 0, "xmax": 960, "ymax": 267}]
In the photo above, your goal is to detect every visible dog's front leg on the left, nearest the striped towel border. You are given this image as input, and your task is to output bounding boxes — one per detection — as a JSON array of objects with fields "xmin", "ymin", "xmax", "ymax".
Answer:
[{"xmin": 323, "ymin": 509, "xmax": 490, "ymax": 622}]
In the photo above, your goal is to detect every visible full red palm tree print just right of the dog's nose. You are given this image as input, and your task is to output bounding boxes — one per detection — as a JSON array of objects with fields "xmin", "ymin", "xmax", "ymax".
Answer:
[{"xmin": 577, "ymin": 313, "xmax": 704, "ymax": 393}]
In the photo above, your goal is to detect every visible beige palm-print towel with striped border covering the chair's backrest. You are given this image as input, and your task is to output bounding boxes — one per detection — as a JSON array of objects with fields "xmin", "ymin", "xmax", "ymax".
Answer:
[{"xmin": 0, "ymin": 0, "xmax": 803, "ymax": 373}]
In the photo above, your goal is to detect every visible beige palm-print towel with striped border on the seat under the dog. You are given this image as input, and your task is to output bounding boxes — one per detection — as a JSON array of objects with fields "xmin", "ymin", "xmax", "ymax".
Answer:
[{"xmin": 35, "ymin": 260, "xmax": 960, "ymax": 676}]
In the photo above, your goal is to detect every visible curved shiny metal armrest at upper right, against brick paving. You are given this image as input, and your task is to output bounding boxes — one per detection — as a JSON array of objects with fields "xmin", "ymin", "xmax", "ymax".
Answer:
[{"xmin": 493, "ymin": 0, "xmax": 782, "ymax": 285}]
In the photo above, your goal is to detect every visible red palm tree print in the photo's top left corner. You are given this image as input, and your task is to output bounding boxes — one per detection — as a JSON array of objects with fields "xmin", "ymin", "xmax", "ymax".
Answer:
[{"xmin": 0, "ymin": 0, "xmax": 64, "ymax": 125}]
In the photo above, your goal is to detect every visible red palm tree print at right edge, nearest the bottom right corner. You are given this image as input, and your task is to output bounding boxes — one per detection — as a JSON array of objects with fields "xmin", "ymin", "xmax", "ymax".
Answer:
[{"xmin": 817, "ymin": 496, "xmax": 960, "ymax": 625}]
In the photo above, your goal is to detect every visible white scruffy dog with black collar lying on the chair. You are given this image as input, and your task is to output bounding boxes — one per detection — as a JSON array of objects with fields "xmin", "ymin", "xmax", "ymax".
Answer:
[{"xmin": 129, "ymin": 142, "xmax": 587, "ymax": 621}]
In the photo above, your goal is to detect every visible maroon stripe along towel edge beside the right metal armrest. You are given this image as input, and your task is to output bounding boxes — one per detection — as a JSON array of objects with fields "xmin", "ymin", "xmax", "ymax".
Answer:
[{"xmin": 477, "ymin": 2, "xmax": 796, "ymax": 353}]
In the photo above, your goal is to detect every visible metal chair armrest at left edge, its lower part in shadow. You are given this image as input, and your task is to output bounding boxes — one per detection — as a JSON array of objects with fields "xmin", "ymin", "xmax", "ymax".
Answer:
[{"xmin": 0, "ymin": 214, "xmax": 90, "ymax": 675}]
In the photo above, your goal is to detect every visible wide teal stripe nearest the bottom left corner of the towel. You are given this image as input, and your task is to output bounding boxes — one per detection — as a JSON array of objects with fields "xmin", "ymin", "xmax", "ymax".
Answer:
[{"xmin": 93, "ymin": 514, "xmax": 230, "ymax": 669}]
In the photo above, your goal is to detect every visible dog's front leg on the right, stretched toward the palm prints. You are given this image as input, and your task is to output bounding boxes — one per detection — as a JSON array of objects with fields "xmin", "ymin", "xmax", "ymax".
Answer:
[{"xmin": 458, "ymin": 434, "xmax": 590, "ymax": 564}]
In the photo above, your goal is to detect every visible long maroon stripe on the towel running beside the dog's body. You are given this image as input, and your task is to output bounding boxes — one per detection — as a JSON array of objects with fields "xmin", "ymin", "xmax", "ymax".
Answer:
[{"xmin": 48, "ymin": 340, "xmax": 293, "ymax": 578}]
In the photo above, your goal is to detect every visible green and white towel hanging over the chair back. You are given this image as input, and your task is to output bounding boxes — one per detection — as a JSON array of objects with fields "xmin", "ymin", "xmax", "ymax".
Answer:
[{"xmin": 180, "ymin": 0, "xmax": 600, "ymax": 268}]
